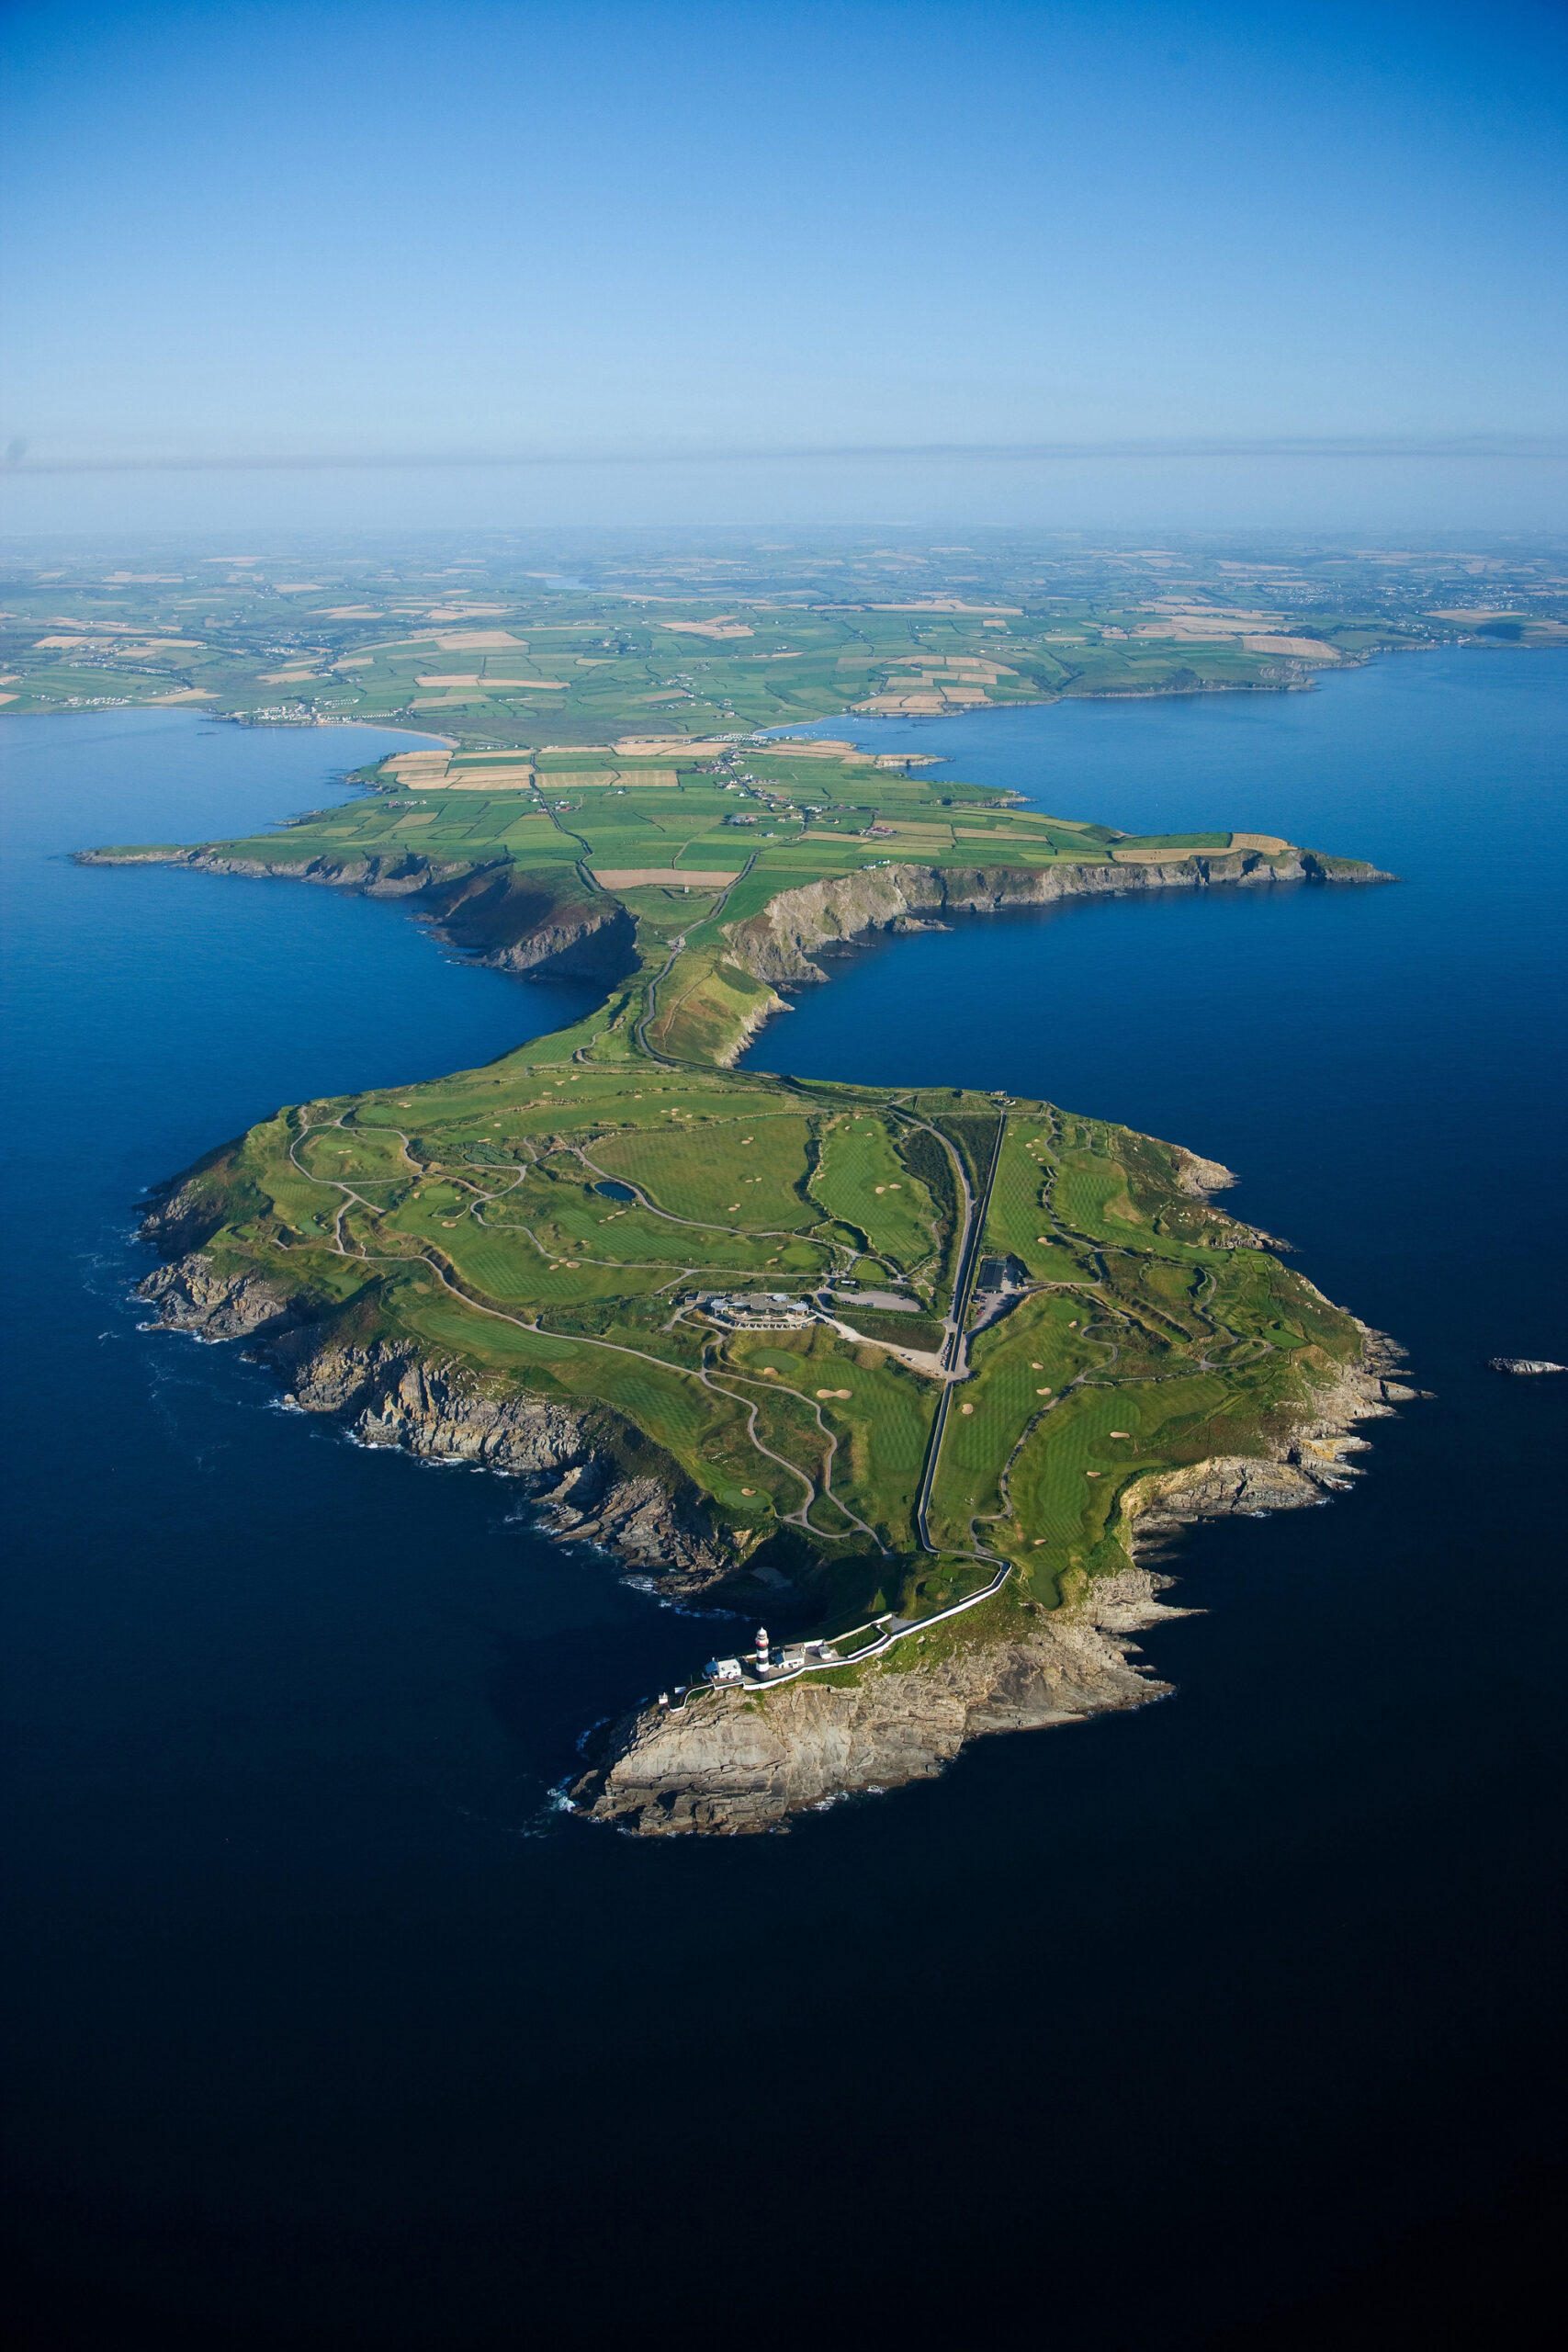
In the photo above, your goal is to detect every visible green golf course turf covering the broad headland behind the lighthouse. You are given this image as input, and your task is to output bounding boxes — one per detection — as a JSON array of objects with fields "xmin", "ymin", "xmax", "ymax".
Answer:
[{"xmin": 152, "ymin": 945, "xmax": 1359, "ymax": 1621}]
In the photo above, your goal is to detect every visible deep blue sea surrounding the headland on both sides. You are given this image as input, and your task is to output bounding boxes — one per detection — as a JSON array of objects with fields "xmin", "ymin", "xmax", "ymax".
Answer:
[{"xmin": 0, "ymin": 673, "xmax": 1568, "ymax": 2352}]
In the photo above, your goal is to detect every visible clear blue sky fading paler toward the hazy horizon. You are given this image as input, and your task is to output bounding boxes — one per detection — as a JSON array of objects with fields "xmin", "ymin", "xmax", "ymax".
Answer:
[{"xmin": 0, "ymin": 0, "xmax": 1568, "ymax": 532}]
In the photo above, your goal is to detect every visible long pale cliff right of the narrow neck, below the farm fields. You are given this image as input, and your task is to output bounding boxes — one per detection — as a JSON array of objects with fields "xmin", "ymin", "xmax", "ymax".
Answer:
[{"xmin": 728, "ymin": 849, "xmax": 1389, "ymax": 988}]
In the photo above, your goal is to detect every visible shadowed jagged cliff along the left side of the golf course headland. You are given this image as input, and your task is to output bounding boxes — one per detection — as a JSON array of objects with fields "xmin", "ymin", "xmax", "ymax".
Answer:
[{"xmin": 141, "ymin": 1241, "xmax": 733, "ymax": 1595}]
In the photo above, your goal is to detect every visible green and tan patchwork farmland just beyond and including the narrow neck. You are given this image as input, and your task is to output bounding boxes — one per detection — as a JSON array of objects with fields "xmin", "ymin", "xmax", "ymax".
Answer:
[{"xmin": 85, "ymin": 743, "xmax": 1357, "ymax": 1081}]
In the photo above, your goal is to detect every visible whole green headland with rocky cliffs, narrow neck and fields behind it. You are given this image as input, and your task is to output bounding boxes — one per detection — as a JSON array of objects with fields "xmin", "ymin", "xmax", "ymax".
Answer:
[{"xmin": 97, "ymin": 741, "xmax": 1408, "ymax": 1835}]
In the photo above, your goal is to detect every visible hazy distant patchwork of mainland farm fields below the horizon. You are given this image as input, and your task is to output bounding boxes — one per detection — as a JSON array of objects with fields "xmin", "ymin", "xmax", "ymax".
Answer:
[{"xmin": 0, "ymin": 534, "xmax": 1541, "ymax": 738}]
